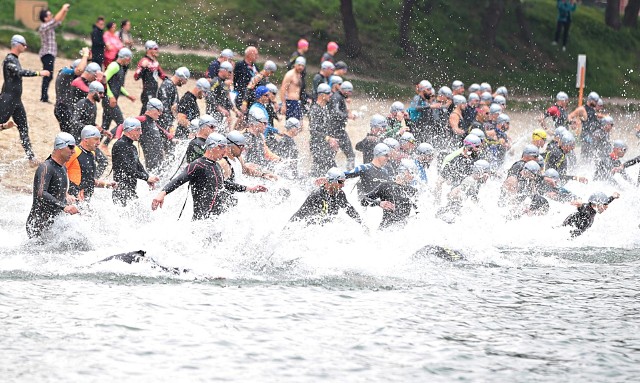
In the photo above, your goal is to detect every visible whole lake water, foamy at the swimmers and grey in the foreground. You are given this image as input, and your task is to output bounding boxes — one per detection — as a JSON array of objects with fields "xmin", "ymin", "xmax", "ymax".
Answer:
[{"xmin": 0, "ymin": 157, "xmax": 640, "ymax": 382}]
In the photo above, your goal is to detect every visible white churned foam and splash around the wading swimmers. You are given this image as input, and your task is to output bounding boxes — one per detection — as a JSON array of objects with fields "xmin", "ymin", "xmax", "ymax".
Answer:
[{"xmin": 0, "ymin": 155, "xmax": 640, "ymax": 280}]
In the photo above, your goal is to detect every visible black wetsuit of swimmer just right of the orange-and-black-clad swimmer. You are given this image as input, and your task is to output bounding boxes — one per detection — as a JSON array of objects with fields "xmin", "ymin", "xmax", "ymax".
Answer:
[{"xmin": 111, "ymin": 135, "xmax": 149, "ymax": 206}]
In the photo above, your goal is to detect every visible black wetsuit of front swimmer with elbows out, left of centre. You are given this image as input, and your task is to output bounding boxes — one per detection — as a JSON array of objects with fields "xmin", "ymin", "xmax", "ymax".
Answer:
[{"xmin": 162, "ymin": 157, "xmax": 241, "ymax": 220}]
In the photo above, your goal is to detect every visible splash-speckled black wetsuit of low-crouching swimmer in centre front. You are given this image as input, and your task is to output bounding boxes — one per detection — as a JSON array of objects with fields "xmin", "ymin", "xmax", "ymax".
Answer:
[{"xmin": 290, "ymin": 187, "xmax": 361, "ymax": 225}]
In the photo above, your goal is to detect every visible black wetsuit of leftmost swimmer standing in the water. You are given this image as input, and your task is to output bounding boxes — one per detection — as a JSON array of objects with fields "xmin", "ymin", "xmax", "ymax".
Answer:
[{"xmin": 27, "ymin": 157, "xmax": 69, "ymax": 238}]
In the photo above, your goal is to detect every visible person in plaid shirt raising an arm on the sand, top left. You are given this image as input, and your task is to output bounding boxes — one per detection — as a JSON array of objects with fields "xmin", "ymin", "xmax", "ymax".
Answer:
[{"xmin": 38, "ymin": 4, "xmax": 69, "ymax": 103}]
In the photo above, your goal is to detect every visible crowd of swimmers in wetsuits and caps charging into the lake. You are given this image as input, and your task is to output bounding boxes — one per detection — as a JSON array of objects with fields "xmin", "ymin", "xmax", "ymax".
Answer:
[{"xmin": 0, "ymin": 35, "xmax": 640, "ymax": 237}]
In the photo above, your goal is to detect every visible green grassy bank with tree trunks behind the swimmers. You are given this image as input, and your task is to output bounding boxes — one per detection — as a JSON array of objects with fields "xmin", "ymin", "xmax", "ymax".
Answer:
[{"xmin": 0, "ymin": 0, "xmax": 640, "ymax": 98}]
